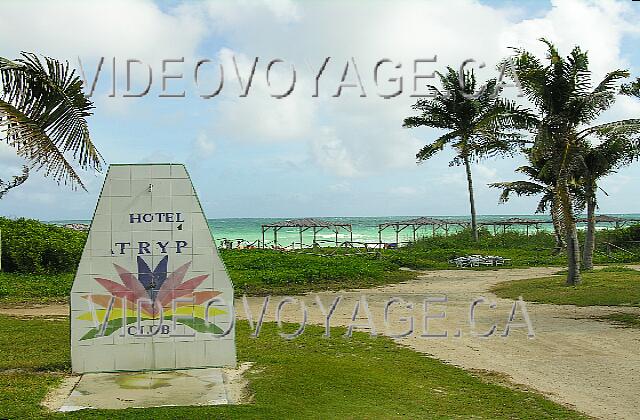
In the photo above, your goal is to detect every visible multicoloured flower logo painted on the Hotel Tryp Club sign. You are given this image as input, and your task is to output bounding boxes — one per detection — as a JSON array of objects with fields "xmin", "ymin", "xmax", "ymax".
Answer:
[{"xmin": 77, "ymin": 256, "xmax": 226, "ymax": 340}]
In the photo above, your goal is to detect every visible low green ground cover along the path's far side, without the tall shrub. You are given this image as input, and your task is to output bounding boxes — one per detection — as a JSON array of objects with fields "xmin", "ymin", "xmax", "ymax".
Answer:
[{"xmin": 0, "ymin": 227, "xmax": 640, "ymax": 304}]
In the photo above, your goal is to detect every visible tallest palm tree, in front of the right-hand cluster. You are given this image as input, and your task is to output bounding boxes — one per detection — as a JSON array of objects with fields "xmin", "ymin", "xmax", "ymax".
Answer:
[{"xmin": 504, "ymin": 39, "xmax": 640, "ymax": 285}]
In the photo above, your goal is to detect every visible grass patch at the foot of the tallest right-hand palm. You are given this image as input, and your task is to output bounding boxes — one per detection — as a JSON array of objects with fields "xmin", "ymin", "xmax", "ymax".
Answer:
[{"xmin": 492, "ymin": 267, "xmax": 640, "ymax": 306}]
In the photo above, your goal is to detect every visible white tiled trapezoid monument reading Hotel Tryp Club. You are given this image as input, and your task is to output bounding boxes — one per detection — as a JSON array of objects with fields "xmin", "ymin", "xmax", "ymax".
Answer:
[{"xmin": 71, "ymin": 164, "xmax": 236, "ymax": 373}]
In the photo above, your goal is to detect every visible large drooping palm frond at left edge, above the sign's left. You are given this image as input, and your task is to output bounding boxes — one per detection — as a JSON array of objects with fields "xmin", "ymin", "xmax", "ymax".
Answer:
[{"xmin": 0, "ymin": 53, "xmax": 102, "ymax": 189}]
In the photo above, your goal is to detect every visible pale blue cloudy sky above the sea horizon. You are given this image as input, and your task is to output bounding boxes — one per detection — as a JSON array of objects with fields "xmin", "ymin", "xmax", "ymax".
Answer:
[{"xmin": 0, "ymin": 0, "xmax": 640, "ymax": 220}]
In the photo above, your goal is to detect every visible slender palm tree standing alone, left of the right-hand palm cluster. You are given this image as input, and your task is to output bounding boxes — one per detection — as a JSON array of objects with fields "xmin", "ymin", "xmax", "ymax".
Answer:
[{"xmin": 403, "ymin": 67, "xmax": 532, "ymax": 241}]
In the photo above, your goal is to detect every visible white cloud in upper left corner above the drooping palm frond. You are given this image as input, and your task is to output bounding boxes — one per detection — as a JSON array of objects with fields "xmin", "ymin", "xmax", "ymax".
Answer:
[{"xmin": 0, "ymin": 0, "xmax": 209, "ymax": 117}]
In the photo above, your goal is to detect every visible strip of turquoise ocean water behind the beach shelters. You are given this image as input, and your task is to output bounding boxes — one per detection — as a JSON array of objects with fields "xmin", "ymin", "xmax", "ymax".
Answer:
[{"xmin": 52, "ymin": 214, "xmax": 640, "ymax": 246}]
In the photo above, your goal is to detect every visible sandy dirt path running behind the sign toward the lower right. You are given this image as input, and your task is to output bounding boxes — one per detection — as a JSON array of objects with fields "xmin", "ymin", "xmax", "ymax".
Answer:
[{"xmin": 0, "ymin": 267, "xmax": 640, "ymax": 419}]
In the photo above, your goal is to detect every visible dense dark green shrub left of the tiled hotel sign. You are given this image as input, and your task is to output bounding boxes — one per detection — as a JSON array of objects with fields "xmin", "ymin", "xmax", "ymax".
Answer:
[{"xmin": 0, "ymin": 217, "xmax": 87, "ymax": 274}]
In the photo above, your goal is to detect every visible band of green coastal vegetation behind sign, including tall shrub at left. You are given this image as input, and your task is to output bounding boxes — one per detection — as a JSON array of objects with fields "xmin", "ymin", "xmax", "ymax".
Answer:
[{"xmin": 0, "ymin": 218, "xmax": 640, "ymax": 303}]
